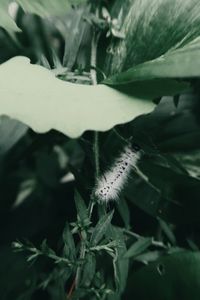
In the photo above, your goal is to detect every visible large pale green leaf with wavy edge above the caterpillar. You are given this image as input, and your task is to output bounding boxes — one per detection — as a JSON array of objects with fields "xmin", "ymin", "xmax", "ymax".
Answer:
[{"xmin": 0, "ymin": 57, "xmax": 154, "ymax": 138}]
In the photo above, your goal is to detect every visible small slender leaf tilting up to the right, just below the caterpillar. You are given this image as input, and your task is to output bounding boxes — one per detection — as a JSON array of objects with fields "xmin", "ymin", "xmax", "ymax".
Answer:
[{"xmin": 90, "ymin": 211, "xmax": 114, "ymax": 246}]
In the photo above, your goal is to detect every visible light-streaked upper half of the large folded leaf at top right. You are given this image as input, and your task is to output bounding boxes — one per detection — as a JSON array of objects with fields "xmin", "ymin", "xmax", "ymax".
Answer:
[{"xmin": 105, "ymin": 0, "xmax": 200, "ymax": 75}]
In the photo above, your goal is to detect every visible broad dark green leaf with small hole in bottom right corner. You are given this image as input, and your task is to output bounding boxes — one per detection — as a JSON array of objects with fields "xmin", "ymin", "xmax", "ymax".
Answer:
[{"xmin": 124, "ymin": 251, "xmax": 200, "ymax": 300}]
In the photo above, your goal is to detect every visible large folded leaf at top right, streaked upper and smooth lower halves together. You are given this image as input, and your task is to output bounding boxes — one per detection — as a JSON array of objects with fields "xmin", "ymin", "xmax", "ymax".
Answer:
[{"xmin": 105, "ymin": 0, "xmax": 200, "ymax": 95}]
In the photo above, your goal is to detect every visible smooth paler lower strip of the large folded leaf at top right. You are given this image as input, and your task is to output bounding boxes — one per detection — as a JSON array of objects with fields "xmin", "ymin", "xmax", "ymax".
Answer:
[{"xmin": 106, "ymin": 38, "xmax": 200, "ymax": 84}]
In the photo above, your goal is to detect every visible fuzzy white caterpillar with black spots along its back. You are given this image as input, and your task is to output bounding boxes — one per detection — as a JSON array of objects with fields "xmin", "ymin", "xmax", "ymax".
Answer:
[{"xmin": 94, "ymin": 145, "xmax": 142, "ymax": 203}]
